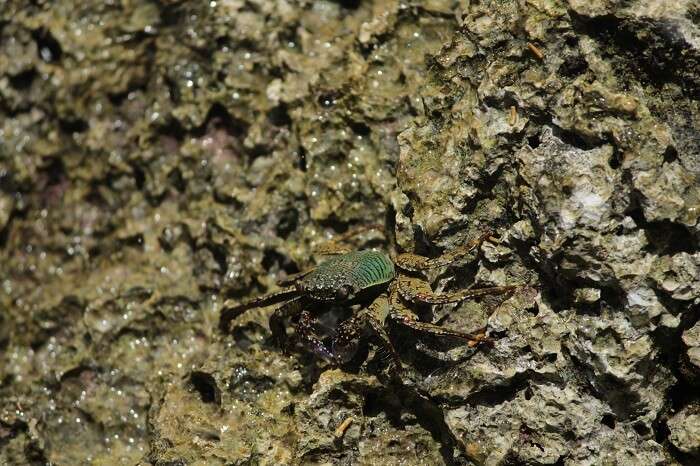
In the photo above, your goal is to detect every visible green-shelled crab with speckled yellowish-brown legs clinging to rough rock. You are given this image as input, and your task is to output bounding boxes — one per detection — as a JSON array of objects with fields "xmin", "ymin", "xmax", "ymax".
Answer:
[{"xmin": 220, "ymin": 226, "xmax": 518, "ymax": 370}]
